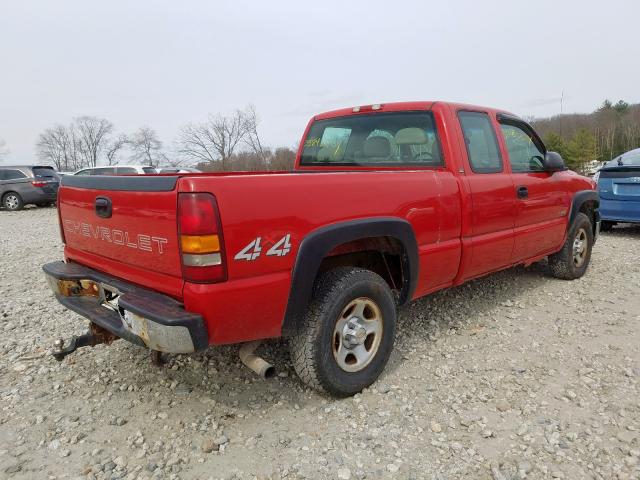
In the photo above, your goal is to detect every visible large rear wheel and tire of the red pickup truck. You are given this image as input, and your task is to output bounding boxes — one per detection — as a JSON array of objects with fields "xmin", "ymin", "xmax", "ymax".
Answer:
[{"xmin": 289, "ymin": 267, "xmax": 396, "ymax": 397}]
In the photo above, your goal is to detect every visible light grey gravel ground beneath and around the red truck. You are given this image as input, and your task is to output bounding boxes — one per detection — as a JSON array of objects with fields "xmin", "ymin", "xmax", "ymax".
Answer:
[{"xmin": 0, "ymin": 209, "xmax": 640, "ymax": 480}]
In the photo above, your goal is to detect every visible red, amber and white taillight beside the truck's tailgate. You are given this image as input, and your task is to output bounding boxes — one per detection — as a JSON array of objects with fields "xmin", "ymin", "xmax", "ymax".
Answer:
[{"xmin": 178, "ymin": 193, "xmax": 227, "ymax": 283}]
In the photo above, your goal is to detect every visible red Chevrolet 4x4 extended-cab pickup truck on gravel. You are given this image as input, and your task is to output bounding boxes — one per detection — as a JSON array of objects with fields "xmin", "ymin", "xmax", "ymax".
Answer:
[{"xmin": 44, "ymin": 102, "xmax": 600, "ymax": 396}]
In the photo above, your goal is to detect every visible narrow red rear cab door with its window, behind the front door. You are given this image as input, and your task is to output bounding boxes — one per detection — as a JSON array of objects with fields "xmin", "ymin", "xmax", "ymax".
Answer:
[{"xmin": 457, "ymin": 110, "xmax": 516, "ymax": 279}]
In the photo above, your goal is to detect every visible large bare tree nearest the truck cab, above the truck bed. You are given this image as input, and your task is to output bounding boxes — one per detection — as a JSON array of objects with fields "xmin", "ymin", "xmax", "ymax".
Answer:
[{"xmin": 178, "ymin": 110, "xmax": 255, "ymax": 170}]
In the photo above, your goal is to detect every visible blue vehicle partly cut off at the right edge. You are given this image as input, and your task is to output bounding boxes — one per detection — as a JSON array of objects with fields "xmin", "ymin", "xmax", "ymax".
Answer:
[{"xmin": 594, "ymin": 148, "xmax": 640, "ymax": 232}]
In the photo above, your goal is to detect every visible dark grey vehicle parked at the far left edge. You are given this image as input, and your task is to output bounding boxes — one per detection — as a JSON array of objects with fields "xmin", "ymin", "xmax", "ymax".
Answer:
[{"xmin": 0, "ymin": 165, "xmax": 60, "ymax": 210}]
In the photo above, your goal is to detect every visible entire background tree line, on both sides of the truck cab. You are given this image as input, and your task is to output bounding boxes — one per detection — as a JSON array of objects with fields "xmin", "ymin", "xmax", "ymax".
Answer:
[{"xmin": 22, "ymin": 100, "xmax": 640, "ymax": 172}]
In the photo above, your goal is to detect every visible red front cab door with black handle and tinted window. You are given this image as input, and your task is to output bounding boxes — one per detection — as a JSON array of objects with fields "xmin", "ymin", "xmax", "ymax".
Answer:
[{"xmin": 498, "ymin": 114, "xmax": 568, "ymax": 263}]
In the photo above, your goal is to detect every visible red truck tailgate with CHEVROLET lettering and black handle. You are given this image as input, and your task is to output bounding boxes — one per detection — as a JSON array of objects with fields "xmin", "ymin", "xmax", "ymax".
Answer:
[{"xmin": 59, "ymin": 175, "xmax": 182, "ymax": 295}]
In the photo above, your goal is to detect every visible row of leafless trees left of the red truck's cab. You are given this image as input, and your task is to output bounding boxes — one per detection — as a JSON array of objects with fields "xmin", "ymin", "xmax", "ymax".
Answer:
[{"xmin": 32, "ymin": 105, "xmax": 295, "ymax": 171}]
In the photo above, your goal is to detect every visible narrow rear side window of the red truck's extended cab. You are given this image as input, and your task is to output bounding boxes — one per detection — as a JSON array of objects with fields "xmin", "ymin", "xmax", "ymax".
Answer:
[{"xmin": 458, "ymin": 112, "xmax": 502, "ymax": 173}]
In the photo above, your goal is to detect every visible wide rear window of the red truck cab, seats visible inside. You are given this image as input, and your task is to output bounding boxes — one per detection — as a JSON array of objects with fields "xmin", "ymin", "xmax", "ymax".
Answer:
[{"xmin": 300, "ymin": 112, "xmax": 443, "ymax": 167}]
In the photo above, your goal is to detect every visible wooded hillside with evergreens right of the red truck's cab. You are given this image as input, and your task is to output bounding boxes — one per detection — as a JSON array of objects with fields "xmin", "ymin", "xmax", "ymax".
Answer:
[{"xmin": 532, "ymin": 100, "xmax": 640, "ymax": 172}]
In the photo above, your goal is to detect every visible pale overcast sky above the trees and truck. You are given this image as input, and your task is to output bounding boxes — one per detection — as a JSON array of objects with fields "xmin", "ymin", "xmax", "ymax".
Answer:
[{"xmin": 0, "ymin": 0, "xmax": 640, "ymax": 163}]
